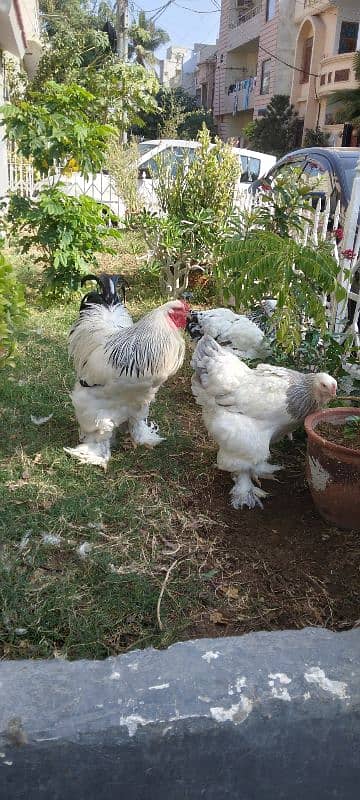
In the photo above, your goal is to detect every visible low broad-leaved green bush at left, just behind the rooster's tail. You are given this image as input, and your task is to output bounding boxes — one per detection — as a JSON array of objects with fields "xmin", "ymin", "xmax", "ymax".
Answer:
[{"xmin": 9, "ymin": 184, "xmax": 121, "ymax": 300}]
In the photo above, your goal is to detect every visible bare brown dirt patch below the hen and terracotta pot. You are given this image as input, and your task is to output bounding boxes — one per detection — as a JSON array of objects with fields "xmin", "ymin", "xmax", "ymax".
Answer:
[{"xmin": 179, "ymin": 442, "xmax": 360, "ymax": 637}]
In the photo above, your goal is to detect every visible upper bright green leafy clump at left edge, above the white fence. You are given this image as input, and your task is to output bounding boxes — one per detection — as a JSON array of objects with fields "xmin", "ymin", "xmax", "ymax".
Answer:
[{"xmin": 0, "ymin": 81, "xmax": 114, "ymax": 176}]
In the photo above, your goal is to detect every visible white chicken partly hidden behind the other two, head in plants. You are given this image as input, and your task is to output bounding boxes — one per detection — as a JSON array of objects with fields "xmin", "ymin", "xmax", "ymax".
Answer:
[{"xmin": 186, "ymin": 300, "xmax": 276, "ymax": 359}]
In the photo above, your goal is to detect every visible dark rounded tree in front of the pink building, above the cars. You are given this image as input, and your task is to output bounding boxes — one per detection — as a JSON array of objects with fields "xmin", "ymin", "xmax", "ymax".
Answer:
[{"xmin": 244, "ymin": 94, "xmax": 302, "ymax": 158}]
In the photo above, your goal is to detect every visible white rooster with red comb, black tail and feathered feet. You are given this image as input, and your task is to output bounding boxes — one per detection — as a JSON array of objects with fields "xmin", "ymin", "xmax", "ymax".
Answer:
[{"xmin": 64, "ymin": 274, "xmax": 189, "ymax": 469}]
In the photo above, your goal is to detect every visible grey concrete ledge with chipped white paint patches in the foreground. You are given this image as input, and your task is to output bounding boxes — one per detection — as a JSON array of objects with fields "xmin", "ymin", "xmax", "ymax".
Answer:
[{"xmin": 0, "ymin": 628, "xmax": 360, "ymax": 800}]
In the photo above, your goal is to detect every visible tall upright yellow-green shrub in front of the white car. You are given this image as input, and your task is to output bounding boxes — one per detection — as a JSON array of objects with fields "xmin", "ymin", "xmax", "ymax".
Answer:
[{"xmin": 132, "ymin": 128, "xmax": 239, "ymax": 295}]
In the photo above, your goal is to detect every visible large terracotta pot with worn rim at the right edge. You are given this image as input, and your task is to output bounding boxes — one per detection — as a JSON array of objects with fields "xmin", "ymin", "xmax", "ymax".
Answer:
[{"xmin": 305, "ymin": 407, "xmax": 360, "ymax": 531}]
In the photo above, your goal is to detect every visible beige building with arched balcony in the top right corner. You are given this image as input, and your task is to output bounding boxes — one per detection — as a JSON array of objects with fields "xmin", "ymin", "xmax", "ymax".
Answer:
[{"xmin": 291, "ymin": 0, "xmax": 360, "ymax": 145}]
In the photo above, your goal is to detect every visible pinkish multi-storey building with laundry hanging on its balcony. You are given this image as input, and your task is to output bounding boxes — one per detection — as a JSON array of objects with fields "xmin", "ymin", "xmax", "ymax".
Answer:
[{"xmin": 213, "ymin": 0, "xmax": 297, "ymax": 139}]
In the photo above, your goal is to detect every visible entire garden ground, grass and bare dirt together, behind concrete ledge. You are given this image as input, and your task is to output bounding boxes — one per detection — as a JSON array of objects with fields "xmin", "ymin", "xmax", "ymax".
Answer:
[{"xmin": 0, "ymin": 234, "xmax": 360, "ymax": 658}]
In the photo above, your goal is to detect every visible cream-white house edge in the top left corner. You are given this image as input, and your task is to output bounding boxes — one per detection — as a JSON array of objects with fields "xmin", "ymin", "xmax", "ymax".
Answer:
[{"xmin": 0, "ymin": 0, "xmax": 41, "ymax": 197}]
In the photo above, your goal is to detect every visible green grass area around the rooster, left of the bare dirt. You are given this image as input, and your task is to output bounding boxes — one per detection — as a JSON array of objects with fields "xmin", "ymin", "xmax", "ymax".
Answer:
[{"xmin": 0, "ymin": 241, "xmax": 219, "ymax": 658}]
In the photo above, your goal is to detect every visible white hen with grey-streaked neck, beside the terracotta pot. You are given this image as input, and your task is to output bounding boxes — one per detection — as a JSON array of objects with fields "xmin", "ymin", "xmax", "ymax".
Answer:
[{"xmin": 191, "ymin": 336, "xmax": 337, "ymax": 508}]
